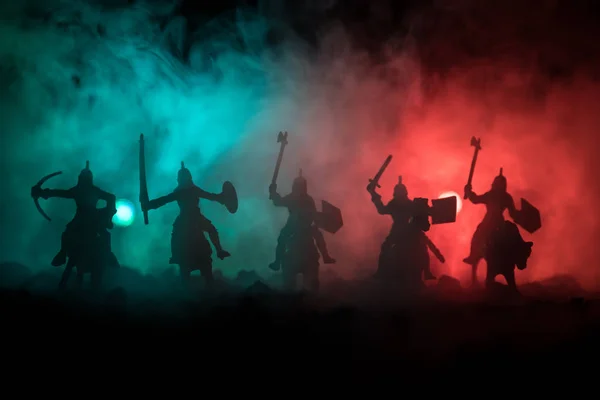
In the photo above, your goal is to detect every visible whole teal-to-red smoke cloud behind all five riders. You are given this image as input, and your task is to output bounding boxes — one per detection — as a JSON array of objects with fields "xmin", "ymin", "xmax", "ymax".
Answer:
[{"xmin": 0, "ymin": 1, "xmax": 600, "ymax": 288}]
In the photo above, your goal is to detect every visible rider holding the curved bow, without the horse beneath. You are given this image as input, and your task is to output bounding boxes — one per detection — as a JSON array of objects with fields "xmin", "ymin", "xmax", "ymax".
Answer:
[{"xmin": 31, "ymin": 161, "xmax": 117, "ymax": 267}]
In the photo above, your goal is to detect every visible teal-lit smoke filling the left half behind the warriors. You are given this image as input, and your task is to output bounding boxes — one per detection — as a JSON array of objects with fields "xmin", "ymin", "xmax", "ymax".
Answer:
[{"xmin": 0, "ymin": 0, "xmax": 310, "ymax": 275}]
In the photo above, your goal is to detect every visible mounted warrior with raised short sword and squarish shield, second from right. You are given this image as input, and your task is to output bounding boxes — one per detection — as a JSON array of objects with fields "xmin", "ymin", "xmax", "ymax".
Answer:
[{"xmin": 367, "ymin": 155, "xmax": 456, "ymax": 290}]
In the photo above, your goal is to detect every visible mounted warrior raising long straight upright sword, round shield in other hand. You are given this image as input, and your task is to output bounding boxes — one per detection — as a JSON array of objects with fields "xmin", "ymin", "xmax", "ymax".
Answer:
[{"xmin": 139, "ymin": 135, "xmax": 238, "ymax": 286}]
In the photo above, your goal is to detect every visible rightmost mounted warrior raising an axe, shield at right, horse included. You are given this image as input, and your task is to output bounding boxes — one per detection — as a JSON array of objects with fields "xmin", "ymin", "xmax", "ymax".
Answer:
[{"xmin": 463, "ymin": 137, "xmax": 542, "ymax": 291}]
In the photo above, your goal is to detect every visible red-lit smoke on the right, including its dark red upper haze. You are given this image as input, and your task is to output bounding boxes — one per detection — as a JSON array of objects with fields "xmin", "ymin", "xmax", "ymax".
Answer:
[{"xmin": 270, "ymin": 2, "xmax": 600, "ymax": 289}]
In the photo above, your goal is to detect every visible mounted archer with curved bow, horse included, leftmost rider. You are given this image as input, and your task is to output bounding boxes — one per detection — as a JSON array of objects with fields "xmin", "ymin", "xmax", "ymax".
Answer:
[{"xmin": 31, "ymin": 161, "xmax": 119, "ymax": 289}]
